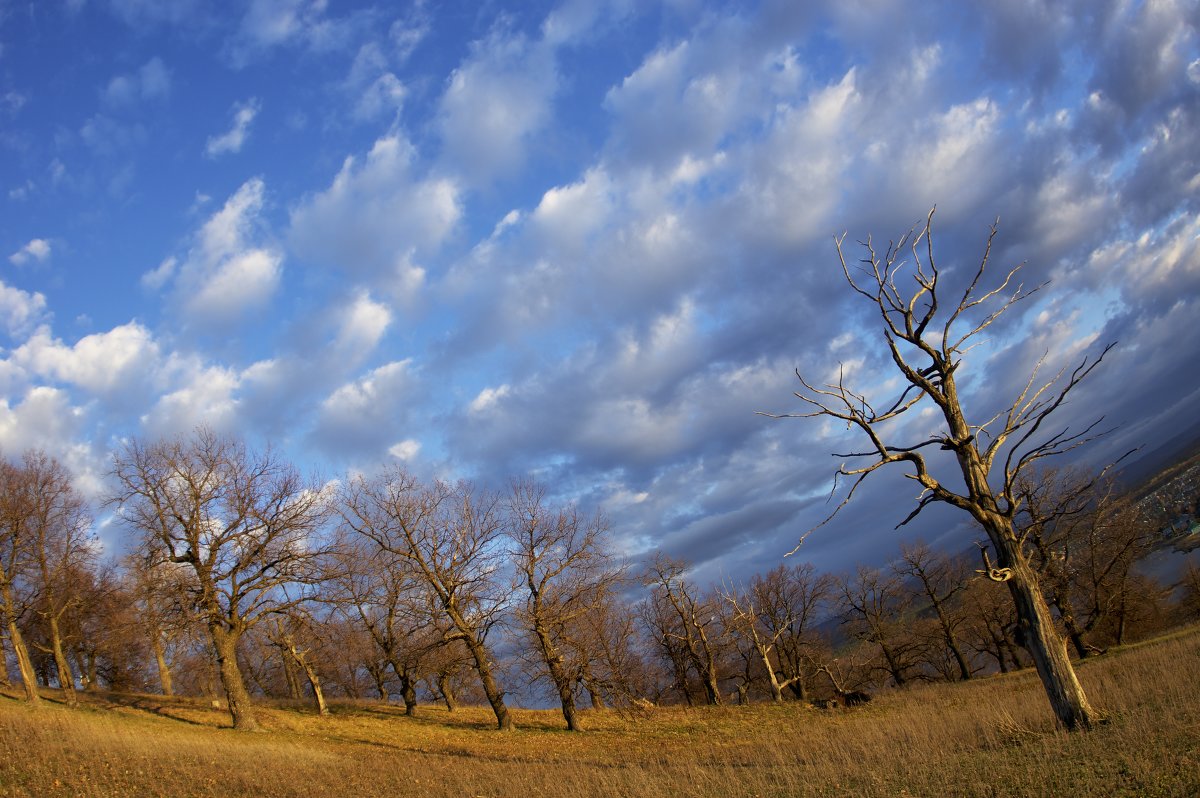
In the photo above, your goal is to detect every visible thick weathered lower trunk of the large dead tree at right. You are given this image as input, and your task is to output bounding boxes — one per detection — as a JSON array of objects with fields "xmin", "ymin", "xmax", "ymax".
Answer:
[{"xmin": 989, "ymin": 529, "xmax": 1098, "ymax": 730}]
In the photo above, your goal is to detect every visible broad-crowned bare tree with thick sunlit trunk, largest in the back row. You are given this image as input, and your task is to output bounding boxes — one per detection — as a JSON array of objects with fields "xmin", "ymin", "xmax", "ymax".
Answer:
[{"xmin": 112, "ymin": 428, "xmax": 328, "ymax": 730}]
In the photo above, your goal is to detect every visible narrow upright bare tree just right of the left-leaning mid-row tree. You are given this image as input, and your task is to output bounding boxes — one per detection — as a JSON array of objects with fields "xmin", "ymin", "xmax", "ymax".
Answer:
[{"xmin": 506, "ymin": 482, "xmax": 624, "ymax": 731}]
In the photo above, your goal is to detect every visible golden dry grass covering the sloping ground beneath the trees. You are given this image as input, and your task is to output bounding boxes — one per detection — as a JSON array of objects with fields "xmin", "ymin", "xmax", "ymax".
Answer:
[{"xmin": 0, "ymin": 628, "xmax": 1200, "ymax": 798}]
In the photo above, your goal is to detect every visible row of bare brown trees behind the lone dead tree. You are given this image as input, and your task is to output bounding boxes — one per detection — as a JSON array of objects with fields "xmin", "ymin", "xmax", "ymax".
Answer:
[{"xmin": 0, "ymin": 430, "xmax": 1185, "ymax": 730}]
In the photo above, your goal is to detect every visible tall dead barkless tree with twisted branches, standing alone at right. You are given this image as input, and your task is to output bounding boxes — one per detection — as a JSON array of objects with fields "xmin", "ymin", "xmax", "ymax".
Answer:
[{"xmin": 772, "ymin": 211, "xmax": 1114, "ymax": 730}]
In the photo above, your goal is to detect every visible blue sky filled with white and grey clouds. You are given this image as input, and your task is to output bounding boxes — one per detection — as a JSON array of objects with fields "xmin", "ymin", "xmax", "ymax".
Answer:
[{"xmin": 0, "ymin": 0, "xmax": 1200, "ymax": 581}]
